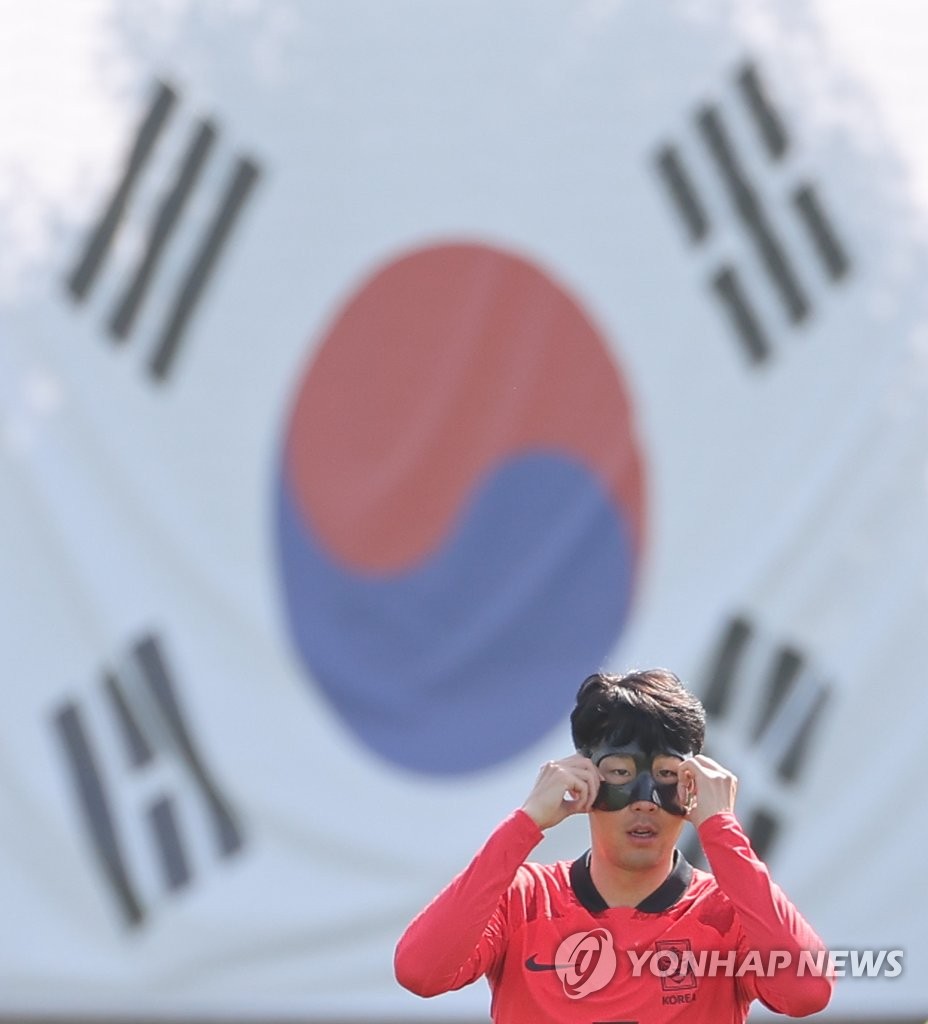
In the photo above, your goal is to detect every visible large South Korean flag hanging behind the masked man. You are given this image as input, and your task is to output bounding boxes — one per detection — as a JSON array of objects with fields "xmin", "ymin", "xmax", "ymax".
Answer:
[{"xmin": 0, "ymin": 0, "xmax": 928, "ymax": 1020}]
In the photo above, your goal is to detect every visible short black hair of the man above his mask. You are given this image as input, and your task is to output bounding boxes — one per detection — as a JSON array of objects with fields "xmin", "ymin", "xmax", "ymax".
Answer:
[{"xmin": 571, "ymin": 669, "xmax": 706, "ymax": 754}]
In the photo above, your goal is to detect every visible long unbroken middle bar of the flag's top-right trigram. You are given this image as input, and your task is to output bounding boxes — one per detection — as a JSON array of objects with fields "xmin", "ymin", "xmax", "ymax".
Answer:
[{"xmin": 699, "ymin": 104, "xmax": 809, "ymax": 324}]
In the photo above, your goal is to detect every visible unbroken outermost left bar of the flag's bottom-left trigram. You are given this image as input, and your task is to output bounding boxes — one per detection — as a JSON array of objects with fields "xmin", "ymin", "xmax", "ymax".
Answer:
[{"xmin": 54, "ymin": 702, "xmax": 144, "ymax": 925}]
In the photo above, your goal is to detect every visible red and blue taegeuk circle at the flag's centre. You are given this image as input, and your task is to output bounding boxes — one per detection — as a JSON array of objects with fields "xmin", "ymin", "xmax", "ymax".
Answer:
[{"xmin": 277, "ymin": 244, "xmax": 644, "ymax": 775}]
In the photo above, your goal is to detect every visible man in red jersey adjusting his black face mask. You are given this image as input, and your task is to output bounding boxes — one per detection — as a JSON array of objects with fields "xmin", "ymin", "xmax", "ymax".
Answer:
[{"xmin": 395, "ymin": 669, "xmax": 833, "ymax": 1024}]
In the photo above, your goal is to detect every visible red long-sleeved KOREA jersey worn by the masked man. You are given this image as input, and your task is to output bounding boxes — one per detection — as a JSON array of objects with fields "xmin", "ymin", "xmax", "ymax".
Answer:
[{"xmin": 395, "ymin": 810, "xmax": 834, "ymax": 1024}]
